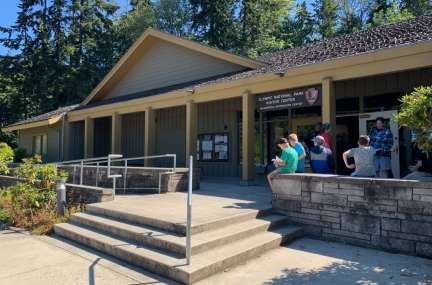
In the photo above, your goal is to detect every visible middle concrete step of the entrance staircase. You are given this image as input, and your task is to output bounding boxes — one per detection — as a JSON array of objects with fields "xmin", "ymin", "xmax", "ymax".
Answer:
[{"xmin": 71, "ymin": 212, "xmax": 287, "ymax": 256}]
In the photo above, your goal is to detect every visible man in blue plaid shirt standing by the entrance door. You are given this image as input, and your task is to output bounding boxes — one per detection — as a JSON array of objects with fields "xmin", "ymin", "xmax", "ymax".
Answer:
[{"xmin": 369, "ymin": 117, "xmax": 394, "ymax": 178}]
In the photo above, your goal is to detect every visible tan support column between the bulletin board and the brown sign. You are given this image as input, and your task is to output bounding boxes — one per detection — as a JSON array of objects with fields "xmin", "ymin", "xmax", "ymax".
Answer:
[{"xmin": 241, "ymin": 90, "xmax": 256, "ymax": 185}]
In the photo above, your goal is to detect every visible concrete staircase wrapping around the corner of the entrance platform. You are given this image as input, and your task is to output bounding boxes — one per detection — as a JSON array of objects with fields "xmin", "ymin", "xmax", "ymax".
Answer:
[{"xmin": 54, "ymin": 203, "xmax": 303, "ymax": 284}]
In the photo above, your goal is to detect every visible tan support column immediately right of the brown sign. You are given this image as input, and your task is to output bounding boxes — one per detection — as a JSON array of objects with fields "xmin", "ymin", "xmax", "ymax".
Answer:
[{"xmin": 321, "ymin": 77, "xmax": 337, "ymax": 167}]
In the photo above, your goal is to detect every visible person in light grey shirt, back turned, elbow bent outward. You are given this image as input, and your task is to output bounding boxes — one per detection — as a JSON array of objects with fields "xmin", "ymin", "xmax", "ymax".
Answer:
[{"xmin": 342, "ymin": 135, "xmax": 375, "ymax": 177}]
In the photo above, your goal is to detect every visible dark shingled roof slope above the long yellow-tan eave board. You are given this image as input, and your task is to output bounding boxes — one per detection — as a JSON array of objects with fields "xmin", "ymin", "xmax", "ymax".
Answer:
[{"xmin": 75, "ymin": 14, "xmax": 432, "ymax": 110}]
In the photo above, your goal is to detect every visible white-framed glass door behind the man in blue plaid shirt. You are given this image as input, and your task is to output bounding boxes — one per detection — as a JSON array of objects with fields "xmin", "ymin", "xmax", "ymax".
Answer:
[{"xmin": 359, "ymin": 110, "xmax": 400, "ymax": 178}]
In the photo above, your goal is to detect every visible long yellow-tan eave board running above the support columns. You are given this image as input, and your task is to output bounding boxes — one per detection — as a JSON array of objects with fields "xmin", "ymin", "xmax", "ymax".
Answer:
[{"xmin": 68, "ymin": 42, "xmax": 432, "ymax": 122}]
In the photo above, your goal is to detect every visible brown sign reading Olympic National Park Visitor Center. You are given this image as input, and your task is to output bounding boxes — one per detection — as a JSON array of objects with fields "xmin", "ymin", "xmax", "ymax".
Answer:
[{"xmin": 256, "ymin": 86, "xmax": 322, "ymax": 112}]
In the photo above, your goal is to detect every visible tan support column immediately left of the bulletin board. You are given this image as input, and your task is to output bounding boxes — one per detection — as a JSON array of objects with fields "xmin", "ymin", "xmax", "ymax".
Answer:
[{"xmin": 186, "ymin": 100, "xmax": 198, "ymax": 167}]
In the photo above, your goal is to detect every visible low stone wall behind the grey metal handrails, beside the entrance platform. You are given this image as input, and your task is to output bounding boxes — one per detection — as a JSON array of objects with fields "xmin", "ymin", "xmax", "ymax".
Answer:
[{"xmin": 58, "ymin": 165, "xmax": 200, "ymax": 193}]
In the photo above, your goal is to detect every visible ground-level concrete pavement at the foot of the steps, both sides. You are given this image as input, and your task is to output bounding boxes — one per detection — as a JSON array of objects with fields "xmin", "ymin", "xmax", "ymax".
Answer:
[{"xmin": 0, "ymin": 231, "xmax": 432, "ymax": 285}]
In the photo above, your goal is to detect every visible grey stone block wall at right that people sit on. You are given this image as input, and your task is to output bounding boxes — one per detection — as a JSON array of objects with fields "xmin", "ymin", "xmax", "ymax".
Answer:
[{"xmin": 272, "ymin": 174, "xmax": 432, "ymax": 258}]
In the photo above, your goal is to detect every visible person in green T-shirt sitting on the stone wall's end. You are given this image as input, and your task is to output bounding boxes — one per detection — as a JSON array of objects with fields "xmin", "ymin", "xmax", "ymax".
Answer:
[{"xmin": 267, "ymin": 138, "xmax": 298, "ymax": 189}]
